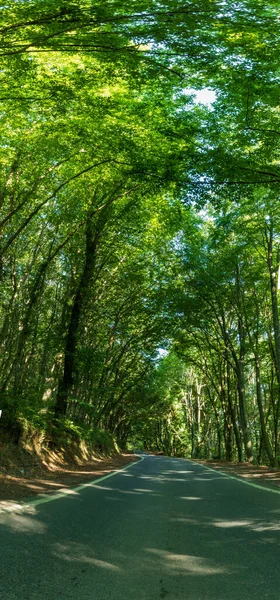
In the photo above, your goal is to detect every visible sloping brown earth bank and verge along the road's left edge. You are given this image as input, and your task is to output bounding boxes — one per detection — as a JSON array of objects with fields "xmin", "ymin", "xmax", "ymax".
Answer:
[{"xmin": 0, "ymin": 444, "xmax": 138, "ymax": 508}]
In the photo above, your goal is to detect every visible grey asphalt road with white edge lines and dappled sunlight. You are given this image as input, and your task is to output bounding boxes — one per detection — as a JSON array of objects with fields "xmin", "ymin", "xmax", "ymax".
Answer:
[{"xmin": 0, "ymin": 456, "xmax": 280, "ymax": 600}]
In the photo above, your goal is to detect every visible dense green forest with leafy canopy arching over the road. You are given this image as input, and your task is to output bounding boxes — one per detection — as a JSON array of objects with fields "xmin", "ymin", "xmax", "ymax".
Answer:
[{"xmin": 0, "ymin": 0, "xmax": 280, "ymax": 466}]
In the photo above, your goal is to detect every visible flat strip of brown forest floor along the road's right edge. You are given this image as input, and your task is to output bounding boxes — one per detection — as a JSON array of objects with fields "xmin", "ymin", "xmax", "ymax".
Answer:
[{"xmin": 192, "ymin": 459, "xmax": 280, "ymax": 488}]
